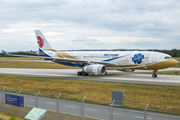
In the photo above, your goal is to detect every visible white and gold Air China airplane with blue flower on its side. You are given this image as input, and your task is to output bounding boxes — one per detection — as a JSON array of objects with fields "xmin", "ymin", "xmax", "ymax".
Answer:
[{"xmin": 3, "ymin": 30, "xmax": 178, "ymax": 78}]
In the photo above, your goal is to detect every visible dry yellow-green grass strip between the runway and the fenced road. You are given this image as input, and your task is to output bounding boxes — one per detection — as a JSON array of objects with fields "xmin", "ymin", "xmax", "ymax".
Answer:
[{"xmin": 0, "ymin": 75, "xmax": 180, "ymax": 114}]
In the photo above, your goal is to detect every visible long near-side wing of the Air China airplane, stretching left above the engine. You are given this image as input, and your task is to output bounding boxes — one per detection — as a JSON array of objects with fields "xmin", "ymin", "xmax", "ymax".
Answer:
[{"xmin": 2, "ymin": 50, "xmax": 114, "ymax": 66}]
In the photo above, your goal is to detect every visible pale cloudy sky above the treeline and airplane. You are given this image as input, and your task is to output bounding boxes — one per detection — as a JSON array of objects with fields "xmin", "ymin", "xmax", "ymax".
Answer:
[{"xmin": 0, "ymin": 0, "xmax": 180, "ymax": 51}]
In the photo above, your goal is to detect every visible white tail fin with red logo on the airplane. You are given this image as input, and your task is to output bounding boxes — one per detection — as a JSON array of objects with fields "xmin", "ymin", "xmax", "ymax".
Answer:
[{"xmin": 35, "ymin": 30, "xmax": 52, "ymax": 51}]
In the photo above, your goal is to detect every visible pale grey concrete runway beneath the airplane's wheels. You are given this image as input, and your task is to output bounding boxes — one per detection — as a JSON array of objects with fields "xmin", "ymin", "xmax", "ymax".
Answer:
[{"xmin": 0, "ymin": 68, "xmax": 180, "ymax": 86}]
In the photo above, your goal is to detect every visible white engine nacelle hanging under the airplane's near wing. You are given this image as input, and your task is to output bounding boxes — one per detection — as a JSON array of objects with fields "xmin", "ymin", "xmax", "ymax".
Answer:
[{"xmin": 83, "ymin": 64, "xmax": 106, "ymax": 75}]
